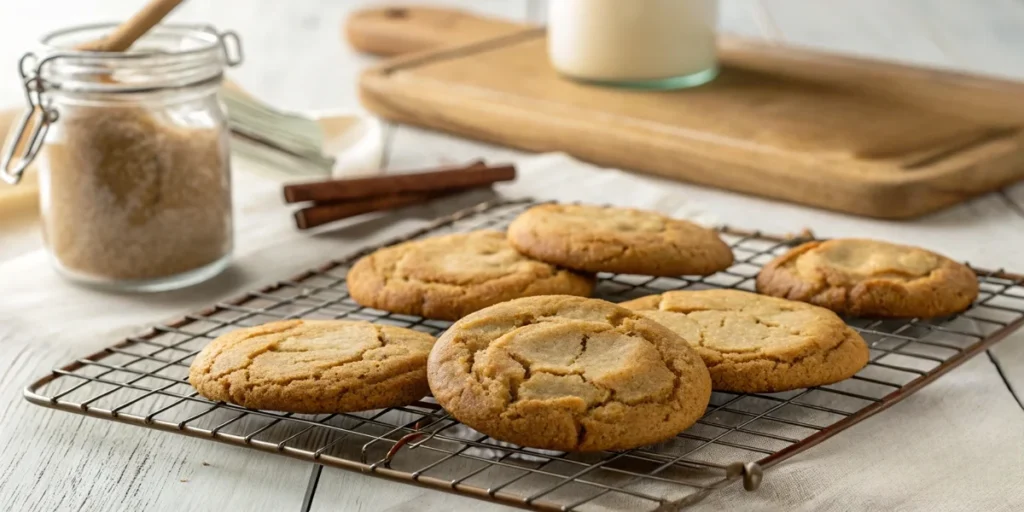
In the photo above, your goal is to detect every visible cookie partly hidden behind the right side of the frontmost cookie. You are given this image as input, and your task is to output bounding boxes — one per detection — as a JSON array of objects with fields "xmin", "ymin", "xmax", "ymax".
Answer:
[{"xmin": 621, "ymin": 290, "xmax": 868, "ymax": 393}]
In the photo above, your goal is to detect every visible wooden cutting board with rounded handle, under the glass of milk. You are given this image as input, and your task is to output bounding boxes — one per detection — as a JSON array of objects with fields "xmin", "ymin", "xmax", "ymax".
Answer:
[{"xmin": 345, "ymin": 7, "xmax": 1024, "ymax": 218}]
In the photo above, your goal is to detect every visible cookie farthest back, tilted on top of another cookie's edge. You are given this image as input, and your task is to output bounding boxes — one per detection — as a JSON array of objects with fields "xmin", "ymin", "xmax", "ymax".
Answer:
[{"xmin": 508, "ymin": 205, "xmax": 732, "ymax": 275}]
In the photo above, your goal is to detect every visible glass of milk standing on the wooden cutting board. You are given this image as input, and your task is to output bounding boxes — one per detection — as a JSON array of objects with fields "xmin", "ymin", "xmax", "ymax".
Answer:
[{"xmin": 548, "ymin": 0, "xmax": 718, "ymax": 89}]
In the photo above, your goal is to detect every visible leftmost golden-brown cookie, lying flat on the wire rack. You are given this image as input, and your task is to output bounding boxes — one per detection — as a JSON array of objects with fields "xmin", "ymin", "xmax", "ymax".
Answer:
[{"xmin": 188, "ymin": 319, "xmax": 434, "ymax": 414}]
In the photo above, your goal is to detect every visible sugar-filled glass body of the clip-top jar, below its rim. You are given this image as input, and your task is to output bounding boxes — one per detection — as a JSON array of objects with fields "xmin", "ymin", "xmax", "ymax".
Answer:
[{"xmin": 37, "ymin": 85, "xmax": 233, "ymax": 291}]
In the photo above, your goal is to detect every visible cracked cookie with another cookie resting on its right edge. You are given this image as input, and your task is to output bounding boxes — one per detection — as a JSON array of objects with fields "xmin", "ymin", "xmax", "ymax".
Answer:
[{"xmin": 348, "ymin": 230, "xmax": 594, "ymax": 321}]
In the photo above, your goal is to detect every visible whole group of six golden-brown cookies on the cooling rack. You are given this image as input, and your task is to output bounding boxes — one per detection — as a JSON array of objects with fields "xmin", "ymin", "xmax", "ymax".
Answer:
[{"xmin": 189, "ymin": 205, "xmax": 978, "ymax": 451}]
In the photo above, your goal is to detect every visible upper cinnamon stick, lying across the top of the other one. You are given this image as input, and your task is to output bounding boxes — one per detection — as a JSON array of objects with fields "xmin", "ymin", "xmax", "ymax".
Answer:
[{"xmin": 285, "ymin": 163, "xmax": 516, "ymax": 203}]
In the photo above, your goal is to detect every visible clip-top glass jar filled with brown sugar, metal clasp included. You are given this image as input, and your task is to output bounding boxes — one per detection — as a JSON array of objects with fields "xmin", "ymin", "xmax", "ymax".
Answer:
[{"xmin": 0, "ymin": 25, "xmax": 241, "ymax": 291}]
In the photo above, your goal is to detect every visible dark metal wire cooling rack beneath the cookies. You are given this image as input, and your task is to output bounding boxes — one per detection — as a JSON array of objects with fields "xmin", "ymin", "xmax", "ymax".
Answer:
[{"xmin": 25, "ymin": 201, "xmax": 1024, "ymax": 510}]
